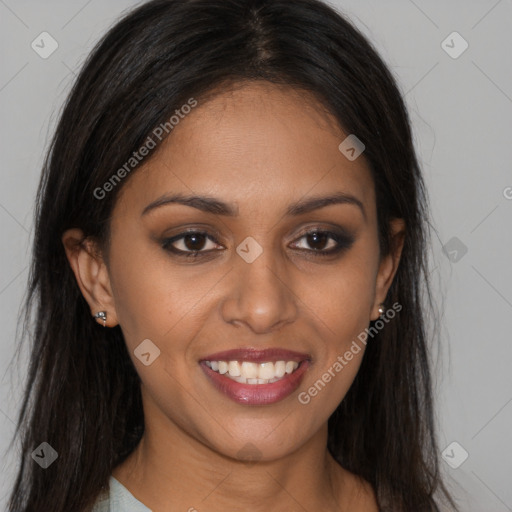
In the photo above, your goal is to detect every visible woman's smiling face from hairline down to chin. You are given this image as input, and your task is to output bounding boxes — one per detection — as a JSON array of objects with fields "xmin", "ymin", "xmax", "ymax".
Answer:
[{"xmin": 62, "ymin": 83, "xmax": 401, "ymax": 460}]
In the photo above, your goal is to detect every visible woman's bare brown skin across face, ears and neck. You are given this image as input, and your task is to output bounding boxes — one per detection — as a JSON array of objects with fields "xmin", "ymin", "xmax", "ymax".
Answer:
[{"xmin": 62, "ymin": 82, "xmax": 404, "ymax": 512}]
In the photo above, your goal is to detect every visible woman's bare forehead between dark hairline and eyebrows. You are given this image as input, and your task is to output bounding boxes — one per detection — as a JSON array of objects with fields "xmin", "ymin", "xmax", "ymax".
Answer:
[{"xmin": 114, "ymin": 82, "xmax": 374, "ymax": 220}]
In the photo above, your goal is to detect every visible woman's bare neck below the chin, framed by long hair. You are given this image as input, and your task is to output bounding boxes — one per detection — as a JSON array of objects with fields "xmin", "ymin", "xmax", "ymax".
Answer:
[{"xmin": 112, "ymin": 392, "xmax": 366, "ymax": 512}]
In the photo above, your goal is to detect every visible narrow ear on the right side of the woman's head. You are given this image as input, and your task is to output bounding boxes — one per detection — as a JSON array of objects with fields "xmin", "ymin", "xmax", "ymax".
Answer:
[{"xmin": 370, "ymin": 218, "xmax": 405, "ymax": 320}]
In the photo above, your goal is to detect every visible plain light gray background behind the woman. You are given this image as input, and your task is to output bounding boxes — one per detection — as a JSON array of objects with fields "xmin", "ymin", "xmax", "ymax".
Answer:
[{"xmin": 0, "ymin": 0, "xmax": 512, "ymax": 512}]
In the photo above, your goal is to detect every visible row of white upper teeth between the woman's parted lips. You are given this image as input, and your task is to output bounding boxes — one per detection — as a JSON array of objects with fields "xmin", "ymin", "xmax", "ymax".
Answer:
[{"xmin": 205, "ymin": 361, "xmax": 299, "ymax": 384}]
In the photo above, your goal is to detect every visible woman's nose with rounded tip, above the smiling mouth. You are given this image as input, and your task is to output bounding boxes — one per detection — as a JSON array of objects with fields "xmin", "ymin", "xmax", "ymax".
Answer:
[{"xmin": 221, "ymin": 245, "xmax": 298, "ymax": 334}]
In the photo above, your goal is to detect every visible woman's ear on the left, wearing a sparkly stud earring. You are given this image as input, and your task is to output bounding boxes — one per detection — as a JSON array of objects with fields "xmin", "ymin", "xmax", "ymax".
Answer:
[{"xmin": 61, "ymin": 229, "xmax": 118, "ymax": 327}]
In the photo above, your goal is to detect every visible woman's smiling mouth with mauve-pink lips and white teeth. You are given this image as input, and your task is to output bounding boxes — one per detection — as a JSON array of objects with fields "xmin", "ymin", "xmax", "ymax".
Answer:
[{"xmin": 199, "ymin": 349, "xmax": 311, "ymax": 405}]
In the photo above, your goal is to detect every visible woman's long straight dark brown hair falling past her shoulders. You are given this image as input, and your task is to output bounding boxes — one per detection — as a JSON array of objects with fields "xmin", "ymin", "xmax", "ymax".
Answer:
[{"xmin": 9, "ymin": 0, "xmax": 454, "ymax": 512}]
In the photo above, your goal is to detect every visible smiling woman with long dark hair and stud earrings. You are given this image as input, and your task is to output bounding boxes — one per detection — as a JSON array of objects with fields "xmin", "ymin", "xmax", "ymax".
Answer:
[{"xmin": 9, "ymin": 0, "xmax": 454, "ymax": 512}]
